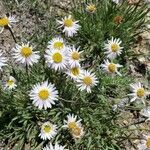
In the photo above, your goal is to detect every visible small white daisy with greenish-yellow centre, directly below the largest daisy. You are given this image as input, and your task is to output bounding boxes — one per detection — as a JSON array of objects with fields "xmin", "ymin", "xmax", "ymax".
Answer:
[{"xmin": 39, "ymin": 122, "xmax": 57, "ymax": 140}]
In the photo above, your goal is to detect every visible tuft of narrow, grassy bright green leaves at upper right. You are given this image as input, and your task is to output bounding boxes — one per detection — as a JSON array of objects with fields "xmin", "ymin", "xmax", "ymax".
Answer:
[{"xmin": 73, "ymin": 0, "xmax": 148, "ymax": 63}]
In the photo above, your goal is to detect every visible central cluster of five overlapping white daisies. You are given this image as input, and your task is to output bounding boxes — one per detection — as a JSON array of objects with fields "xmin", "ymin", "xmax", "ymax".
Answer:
[{"xmin": 45, "ymin": 23, "xmax": 98, "ymax": 93}]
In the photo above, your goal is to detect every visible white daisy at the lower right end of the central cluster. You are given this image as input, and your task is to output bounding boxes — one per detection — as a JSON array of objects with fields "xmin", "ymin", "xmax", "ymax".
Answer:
[{"xmin": 77, "ymin": 70, "xmax": 98, "ymax": 93}]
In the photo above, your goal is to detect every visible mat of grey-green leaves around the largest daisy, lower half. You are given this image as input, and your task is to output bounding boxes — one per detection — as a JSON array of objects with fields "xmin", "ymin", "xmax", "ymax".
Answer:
[{"xmin": 1, "ymin": 65, "xmax": 131, "ymax": 150}]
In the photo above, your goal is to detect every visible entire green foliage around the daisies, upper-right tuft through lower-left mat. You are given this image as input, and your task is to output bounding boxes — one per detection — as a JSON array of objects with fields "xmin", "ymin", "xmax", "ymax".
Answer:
[{"xmin": 0, "ymin": 0, "xmax": 147, "ymax": 150}]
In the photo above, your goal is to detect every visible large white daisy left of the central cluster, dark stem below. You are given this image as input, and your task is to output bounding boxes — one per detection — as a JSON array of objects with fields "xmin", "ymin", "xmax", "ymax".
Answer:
[{"xmin": 12, "ymin": 43, "xmax": 40, "ymax": 66}]
